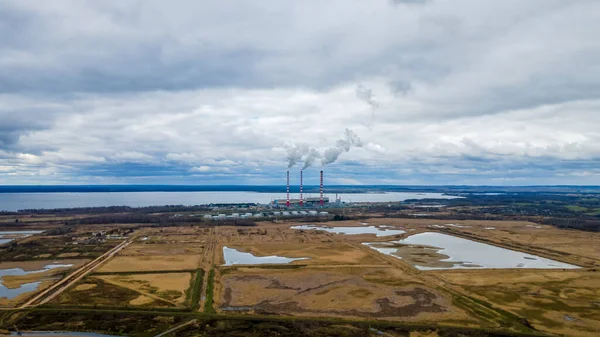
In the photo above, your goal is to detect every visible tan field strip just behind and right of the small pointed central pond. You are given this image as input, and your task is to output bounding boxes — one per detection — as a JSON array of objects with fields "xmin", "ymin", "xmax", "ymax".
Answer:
[{"xmin": 219, "ymin": 242, "xmax": 386, "ymax": 265}]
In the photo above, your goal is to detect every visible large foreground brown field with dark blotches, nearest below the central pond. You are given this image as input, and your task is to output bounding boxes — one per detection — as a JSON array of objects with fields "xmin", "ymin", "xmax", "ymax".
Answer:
[{"xmin": 216, "ymin": 266, "xmax": 477, "ymax": 324}]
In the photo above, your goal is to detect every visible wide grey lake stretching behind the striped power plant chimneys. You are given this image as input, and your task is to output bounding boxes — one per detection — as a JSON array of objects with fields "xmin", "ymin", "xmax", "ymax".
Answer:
[{"xmin": 0, "ymin": 191, "xmax": 457, "ymax": 211}]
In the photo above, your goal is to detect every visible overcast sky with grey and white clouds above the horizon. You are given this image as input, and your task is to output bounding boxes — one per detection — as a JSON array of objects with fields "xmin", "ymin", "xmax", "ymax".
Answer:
[{"xmin": 0, "ymin": 0, "xmax": 600, "ymax": 185}]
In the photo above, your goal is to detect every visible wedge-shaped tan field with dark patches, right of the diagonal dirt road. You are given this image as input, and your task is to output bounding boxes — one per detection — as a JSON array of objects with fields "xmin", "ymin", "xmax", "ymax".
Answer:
[{"xmin": 98, "ymin": 273, "xmax": 192, "ymax": 306}]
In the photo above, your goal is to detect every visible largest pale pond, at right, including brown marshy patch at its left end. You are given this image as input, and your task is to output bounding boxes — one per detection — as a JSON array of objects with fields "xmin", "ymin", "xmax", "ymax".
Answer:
[{"xmin": 363, "ymin": 232, "xmax": 579, "ymax": 270}]
